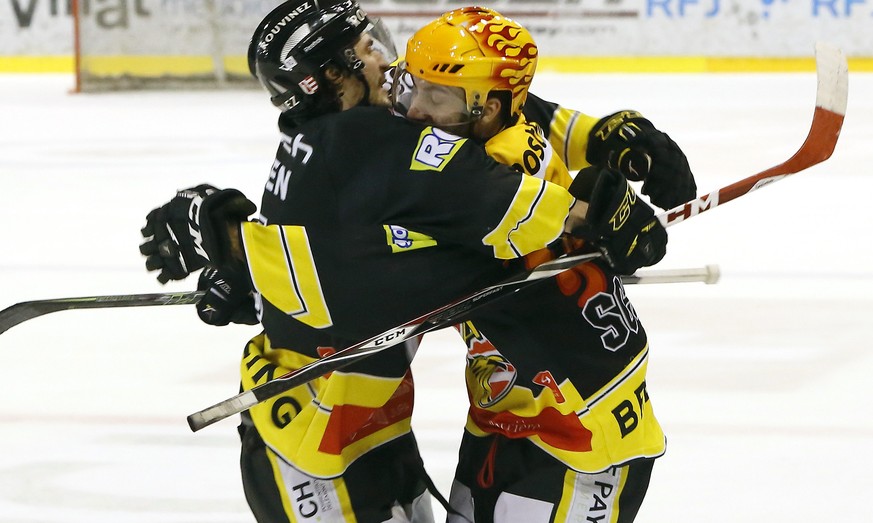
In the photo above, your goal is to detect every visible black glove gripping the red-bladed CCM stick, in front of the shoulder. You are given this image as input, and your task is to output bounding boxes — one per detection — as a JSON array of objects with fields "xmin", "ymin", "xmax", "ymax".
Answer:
[{"xmin": 570, "ymin": 167, "xmax": 667, "ymax": 274}]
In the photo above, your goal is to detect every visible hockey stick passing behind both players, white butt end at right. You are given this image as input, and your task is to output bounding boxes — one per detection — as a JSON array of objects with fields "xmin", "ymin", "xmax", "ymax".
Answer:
[{"xmin": 0, "ymin": 265, "xmax": 719, "ymax": 334}]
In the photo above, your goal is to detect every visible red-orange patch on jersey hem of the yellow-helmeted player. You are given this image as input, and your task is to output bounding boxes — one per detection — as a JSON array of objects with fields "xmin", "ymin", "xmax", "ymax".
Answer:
[{"xmin": 470, "ymin": 407, "xmax": 592, "ymax": 452}]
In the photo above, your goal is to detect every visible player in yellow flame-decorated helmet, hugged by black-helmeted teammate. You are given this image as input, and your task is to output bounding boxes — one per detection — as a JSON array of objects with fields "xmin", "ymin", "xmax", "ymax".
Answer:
[{"xmin": 393, "ymin": 8, "xmax": 665, "ymax": 523}]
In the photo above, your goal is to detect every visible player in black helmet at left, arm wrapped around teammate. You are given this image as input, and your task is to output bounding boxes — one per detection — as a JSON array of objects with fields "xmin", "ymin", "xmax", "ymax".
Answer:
[{"xmin": 143, "ymin": 2, "xmax": 688, "ymax": 521}]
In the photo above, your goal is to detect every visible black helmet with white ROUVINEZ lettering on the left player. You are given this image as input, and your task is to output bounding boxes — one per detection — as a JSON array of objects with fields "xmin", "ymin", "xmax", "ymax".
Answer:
[{"xmin": 248, "ymin": 0, "xmax": 396, "ymax": 120}]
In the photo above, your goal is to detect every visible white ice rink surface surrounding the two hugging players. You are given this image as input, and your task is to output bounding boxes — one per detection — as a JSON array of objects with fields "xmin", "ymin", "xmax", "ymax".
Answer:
[{"xmin": 0, "ymin": 73, "xmax": 873, "ymax": 523}]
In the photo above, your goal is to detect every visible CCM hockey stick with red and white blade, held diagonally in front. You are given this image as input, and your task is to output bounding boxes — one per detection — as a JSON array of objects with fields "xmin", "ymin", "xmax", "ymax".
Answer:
[{"xmin": 188, "ymin": 43, "xmax": 848, "ymax": 431}]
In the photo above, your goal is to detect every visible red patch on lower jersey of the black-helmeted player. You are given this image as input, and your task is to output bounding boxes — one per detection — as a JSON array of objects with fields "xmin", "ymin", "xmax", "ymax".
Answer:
[{"xmin": 318, "ymin": 371, "xmax": 414, "ymax": 456}]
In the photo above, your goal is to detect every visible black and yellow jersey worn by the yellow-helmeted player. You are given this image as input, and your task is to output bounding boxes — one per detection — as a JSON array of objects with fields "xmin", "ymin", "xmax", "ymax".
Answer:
[{"xmin": 458, "ymin": 108, "xmax": 665, "ymax": 472}]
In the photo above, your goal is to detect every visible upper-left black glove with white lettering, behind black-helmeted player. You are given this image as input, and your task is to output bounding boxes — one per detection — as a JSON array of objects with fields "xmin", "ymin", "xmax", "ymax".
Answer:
[{"xmin": 139, "ymin": 185, "xmax": 256, "ymax": 283}]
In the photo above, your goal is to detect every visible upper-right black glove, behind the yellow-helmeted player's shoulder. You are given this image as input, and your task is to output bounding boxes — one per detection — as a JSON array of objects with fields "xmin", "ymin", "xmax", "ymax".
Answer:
[{"xmin": 585, "ymin": 111, "xmax": 697, "ymax": 209}]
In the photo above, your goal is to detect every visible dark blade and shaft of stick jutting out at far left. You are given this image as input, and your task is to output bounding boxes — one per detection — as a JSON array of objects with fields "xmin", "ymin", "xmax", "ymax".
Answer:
[{"xmin": 0, "ymin": 291, "xmax": 203, "ymax": 334}]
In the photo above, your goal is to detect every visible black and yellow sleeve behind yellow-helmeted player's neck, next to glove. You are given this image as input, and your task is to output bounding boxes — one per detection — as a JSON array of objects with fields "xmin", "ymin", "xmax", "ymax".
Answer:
[{"xmin": 524, "ymin": 93, "xmax": 599, "ymax": 171}]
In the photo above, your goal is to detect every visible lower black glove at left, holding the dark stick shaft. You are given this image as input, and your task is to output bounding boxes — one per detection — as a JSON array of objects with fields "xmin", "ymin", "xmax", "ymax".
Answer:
[{"xmin": 197, "ymin": 266, "xmax": 258, "ymax": 326}]
